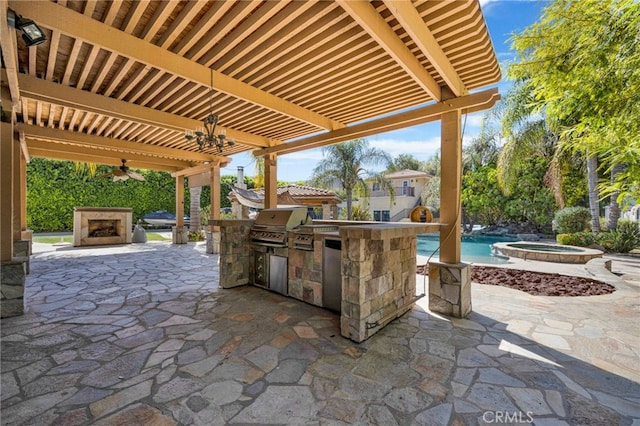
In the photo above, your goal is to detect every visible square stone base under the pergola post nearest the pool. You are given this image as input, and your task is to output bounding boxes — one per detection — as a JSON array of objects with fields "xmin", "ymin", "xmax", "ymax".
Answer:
[{"xmin": 429, "ymin": 261, "xmax": 471, "ymax": 318}]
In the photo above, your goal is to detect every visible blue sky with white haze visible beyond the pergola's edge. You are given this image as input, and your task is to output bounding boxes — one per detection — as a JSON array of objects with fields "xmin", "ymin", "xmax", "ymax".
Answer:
[{"xmin": 221, "ymin": 0, "xmax": 544, "ymax": 182}]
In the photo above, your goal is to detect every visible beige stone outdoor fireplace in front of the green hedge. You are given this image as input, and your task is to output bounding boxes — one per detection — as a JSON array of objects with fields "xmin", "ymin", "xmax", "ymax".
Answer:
[{"xmin": 73, "ymin": 207, "xmax": 132, "ymax": 246}]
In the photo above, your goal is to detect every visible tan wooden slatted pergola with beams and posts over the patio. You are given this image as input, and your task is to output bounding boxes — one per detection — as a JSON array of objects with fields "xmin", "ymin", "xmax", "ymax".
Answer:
[{"xmin": 0, "ymin": 0, "xmax": 501, "ymax": 276}]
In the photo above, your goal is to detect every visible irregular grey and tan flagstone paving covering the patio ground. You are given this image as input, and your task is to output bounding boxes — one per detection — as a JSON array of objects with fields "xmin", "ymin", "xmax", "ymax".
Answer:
[{"xmin": 0, "ymin": 242, "xmax": 640, "ymax": 426}]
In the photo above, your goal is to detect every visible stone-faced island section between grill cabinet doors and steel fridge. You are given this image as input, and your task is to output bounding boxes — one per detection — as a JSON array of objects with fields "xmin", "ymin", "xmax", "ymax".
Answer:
[{"xmin": 288, "ymin": 232, "xmax": 324, "ymax": 306}]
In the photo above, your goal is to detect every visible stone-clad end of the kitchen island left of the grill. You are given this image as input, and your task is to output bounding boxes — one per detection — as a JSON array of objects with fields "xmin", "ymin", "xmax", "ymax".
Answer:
[{"xmin": 209, "ymin": 220, "xmax": 254, "ymax": 288}]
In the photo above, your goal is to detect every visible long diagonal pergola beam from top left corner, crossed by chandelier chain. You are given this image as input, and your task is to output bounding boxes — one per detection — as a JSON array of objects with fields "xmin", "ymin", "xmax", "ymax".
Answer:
[{"xmin": 11, "ymin": 1, "xmax": 344, "ymax": 130}]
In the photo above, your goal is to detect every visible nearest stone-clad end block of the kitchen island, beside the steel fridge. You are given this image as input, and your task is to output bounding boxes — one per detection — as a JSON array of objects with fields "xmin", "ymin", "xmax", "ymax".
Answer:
[{"xmin": 340, "ymin": 225, "xmax": 425, "ymax": 342}]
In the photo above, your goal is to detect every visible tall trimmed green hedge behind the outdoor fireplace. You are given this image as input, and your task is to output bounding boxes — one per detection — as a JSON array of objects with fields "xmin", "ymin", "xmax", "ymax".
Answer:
[{"xmin": 27, "ymin": 158, "xmax": 253, "ymax": 232}]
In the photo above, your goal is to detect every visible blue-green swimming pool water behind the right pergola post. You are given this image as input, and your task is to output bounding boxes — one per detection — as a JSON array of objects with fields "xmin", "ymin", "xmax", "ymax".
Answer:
[{"xmin": 418, "ymin": 234, "xmax": 517, "ymax": 264}]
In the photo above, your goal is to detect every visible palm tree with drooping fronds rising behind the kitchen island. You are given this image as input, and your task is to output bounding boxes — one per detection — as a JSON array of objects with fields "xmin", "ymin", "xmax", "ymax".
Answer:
[{"xmin": 311, "ymin": 139, "xmax": 393, "ymax": 220}]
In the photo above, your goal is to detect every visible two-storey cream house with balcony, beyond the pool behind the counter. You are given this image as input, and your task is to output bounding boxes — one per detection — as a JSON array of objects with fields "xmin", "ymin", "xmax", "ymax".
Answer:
[{"xmin": 359, "ymin": 170, "xmax": 432, "ymax": 222}]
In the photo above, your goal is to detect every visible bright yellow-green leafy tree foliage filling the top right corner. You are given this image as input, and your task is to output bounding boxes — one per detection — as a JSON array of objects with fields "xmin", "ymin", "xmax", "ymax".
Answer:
[{"xmin": 507, "ymin": 0, "xmax": 640, "ymax": 208}]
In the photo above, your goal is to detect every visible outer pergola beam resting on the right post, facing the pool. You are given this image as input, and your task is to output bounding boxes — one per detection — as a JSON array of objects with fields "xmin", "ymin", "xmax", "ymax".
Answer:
[{"xmin": 255, "ymin": 89, "xmax": 500, "ymax": 156}]
